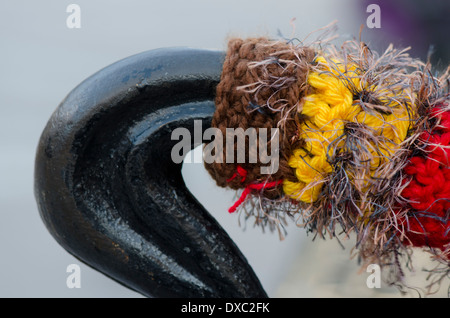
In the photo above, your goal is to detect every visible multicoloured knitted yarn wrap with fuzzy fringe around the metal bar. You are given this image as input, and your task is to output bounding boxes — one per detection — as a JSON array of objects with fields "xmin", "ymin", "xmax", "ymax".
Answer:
[{"xmin": 205, "ymin": 34, "xmax": 450, "ymax": 290}]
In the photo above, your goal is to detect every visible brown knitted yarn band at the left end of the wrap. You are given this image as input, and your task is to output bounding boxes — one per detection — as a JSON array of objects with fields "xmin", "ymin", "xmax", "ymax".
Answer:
[{"xmin": 205, "ymin": 38, "xmax": 315, "ymax": 198}]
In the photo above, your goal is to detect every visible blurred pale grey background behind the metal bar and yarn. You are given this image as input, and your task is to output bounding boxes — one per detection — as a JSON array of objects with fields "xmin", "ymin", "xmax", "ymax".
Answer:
[{"xmin": 0, "ymin": 0, "xmax": 450, "ymax": 297}]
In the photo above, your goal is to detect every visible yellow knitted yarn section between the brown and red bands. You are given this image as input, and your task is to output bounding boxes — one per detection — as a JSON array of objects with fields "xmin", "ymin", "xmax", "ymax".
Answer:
[{"xmin": 283, "ymin": 57, "xmax": 411, "ymax": 203}]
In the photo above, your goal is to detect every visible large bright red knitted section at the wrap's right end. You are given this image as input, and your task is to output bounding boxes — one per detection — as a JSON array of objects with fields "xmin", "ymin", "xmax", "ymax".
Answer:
[{"xmin": 402, "ymin": 106, "xmax": 450, "ymax": 250}]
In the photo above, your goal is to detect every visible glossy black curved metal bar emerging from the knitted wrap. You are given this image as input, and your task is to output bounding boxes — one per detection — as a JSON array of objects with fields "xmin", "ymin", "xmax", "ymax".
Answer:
[{"xmin": 35, "ymin": 48, "xmax": 267, "ymax": 297}]
